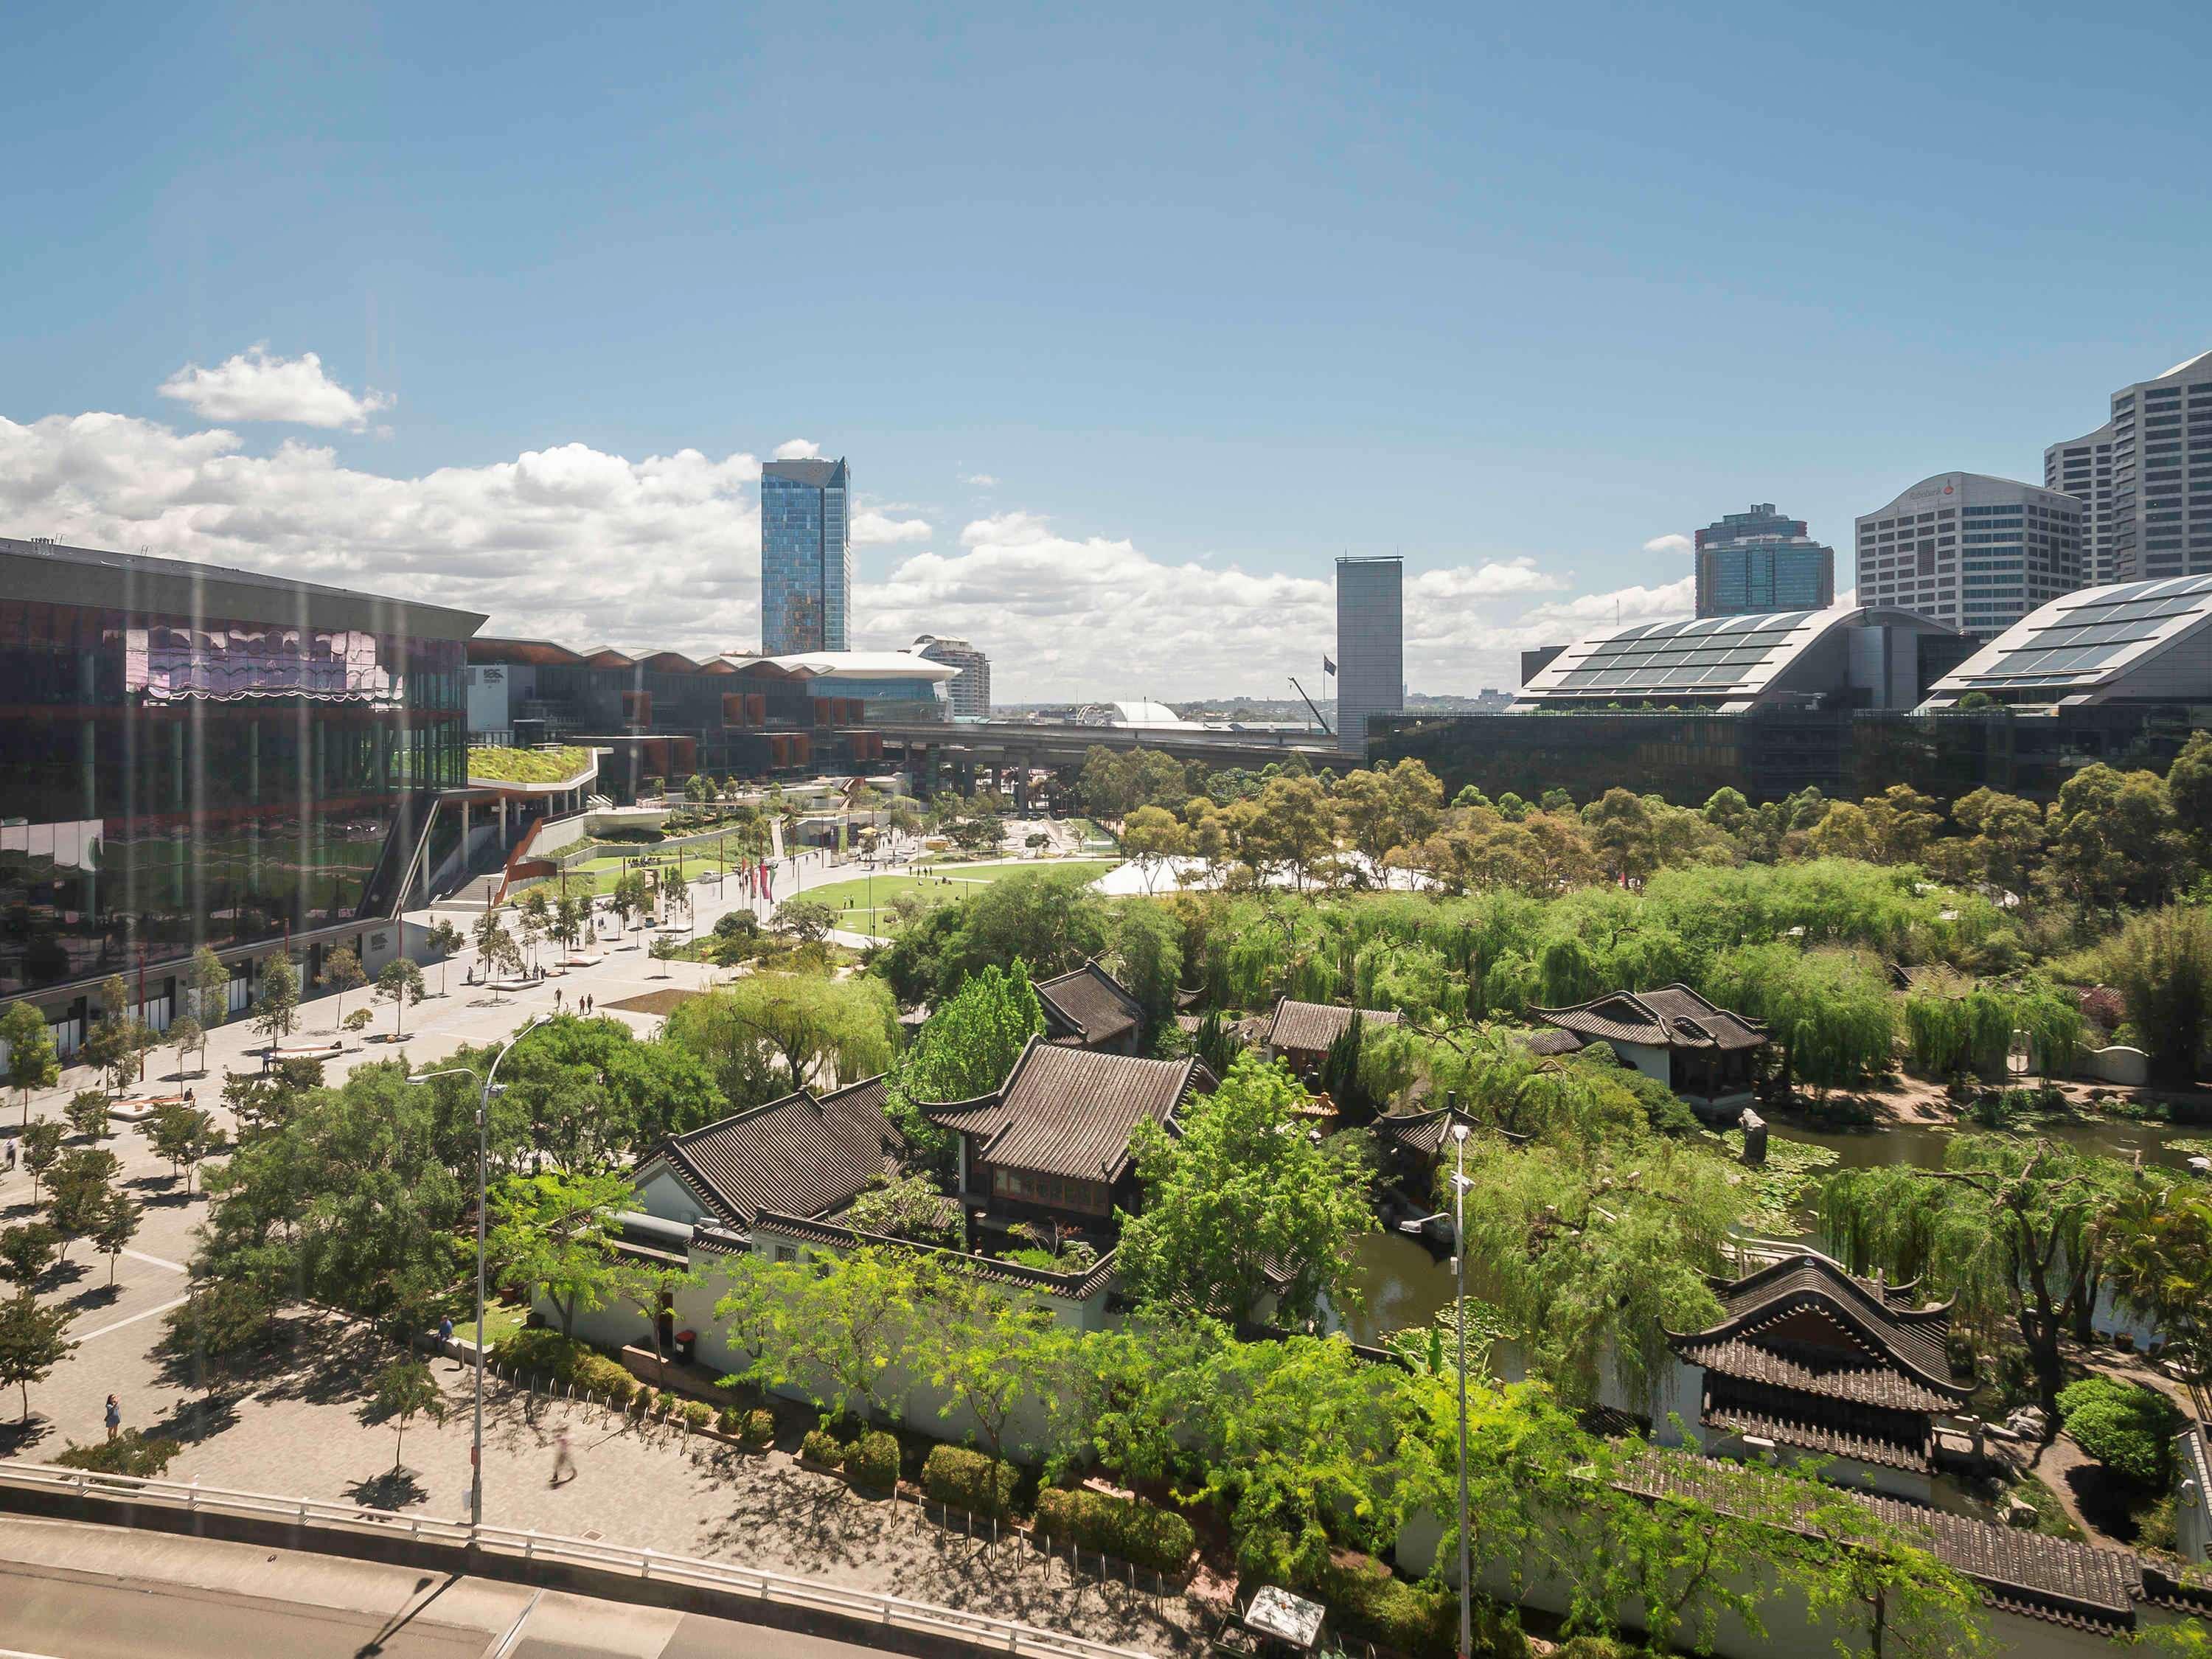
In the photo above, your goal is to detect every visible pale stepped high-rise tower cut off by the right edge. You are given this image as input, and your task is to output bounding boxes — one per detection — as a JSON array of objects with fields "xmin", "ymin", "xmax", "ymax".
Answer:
[{"xmin": 2044, "ymin": 352, "xmax": 2212, "ymax": 582}]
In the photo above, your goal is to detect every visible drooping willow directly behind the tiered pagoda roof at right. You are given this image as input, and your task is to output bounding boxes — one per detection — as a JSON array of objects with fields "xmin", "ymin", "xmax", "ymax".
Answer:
[{"xmin": 1820, "ymin": 1135, "xmax": 2135, "ymax": 1425}]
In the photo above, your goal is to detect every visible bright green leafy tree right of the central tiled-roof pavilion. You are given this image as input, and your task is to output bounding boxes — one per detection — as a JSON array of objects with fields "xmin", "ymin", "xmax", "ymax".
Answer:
[{"xmin": 1117, "ymin": 1053, "xmax": 1376, "ymax": 1327}]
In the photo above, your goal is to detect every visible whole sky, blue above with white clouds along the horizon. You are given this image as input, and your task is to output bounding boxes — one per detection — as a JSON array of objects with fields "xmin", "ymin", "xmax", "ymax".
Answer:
[{"xmin": 0, "ymin": 4, "xmax": 2212, "ymax": 697}]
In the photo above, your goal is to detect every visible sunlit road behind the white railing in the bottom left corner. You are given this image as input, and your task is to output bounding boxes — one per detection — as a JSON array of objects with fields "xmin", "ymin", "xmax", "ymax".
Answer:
[{"xmin": 0, "ymin": 1517, "xmax": 907, "ymax": 1659}]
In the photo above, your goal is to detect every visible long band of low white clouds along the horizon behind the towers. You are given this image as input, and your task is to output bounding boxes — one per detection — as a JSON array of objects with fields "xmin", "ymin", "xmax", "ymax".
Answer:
[{"xmin": 0, "ymin": 394, "xmax": 1692, "ymax": 701}]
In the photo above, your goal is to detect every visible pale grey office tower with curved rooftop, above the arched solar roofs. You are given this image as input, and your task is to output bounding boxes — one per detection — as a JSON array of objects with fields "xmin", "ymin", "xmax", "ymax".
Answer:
[{"xmin": 1858, "ymin": 473, "xmax": 2084, "ymax": 639}]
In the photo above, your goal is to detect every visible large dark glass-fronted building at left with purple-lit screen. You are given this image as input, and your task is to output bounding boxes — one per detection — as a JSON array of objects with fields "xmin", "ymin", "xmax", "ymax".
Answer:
[{"xmin": 0, "ymin": 540, "xmax": 482, "ymax": 1024}]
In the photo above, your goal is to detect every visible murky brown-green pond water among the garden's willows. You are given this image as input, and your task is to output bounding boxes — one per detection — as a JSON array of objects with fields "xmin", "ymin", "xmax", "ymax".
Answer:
[{"xmin": 1345, "ymin": 1119, "xmax": 2212, "ymax": 1343}]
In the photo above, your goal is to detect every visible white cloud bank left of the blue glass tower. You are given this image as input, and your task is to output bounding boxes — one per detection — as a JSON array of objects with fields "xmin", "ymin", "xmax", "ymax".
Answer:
[{"xmin": 0, "ymin": 414, "xmax": 761, "ymax": 653}]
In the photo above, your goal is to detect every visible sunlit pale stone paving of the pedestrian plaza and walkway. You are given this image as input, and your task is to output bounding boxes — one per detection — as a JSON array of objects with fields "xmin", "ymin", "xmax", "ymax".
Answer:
[{"xmin": 0, "ymin": 854, "xmax": 1203, "ymax": 1652}]
